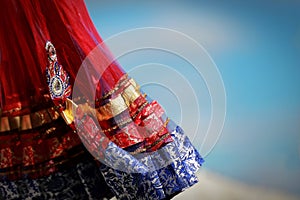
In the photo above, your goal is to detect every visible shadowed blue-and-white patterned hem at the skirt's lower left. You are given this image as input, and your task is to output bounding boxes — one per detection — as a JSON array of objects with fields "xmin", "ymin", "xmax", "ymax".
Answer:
[{"xmin": 0, "ymin": 152, "xmax": 114, "ymax": 200}]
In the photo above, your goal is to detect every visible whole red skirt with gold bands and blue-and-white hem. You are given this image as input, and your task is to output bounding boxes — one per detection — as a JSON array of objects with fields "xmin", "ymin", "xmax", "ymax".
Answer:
[{"xmin": 0, "ymin": 0, "xmax": 203, "ymax": 199}]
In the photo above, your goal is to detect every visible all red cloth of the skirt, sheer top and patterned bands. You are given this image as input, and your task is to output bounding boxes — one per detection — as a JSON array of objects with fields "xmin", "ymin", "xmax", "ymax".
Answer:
[{"xmin": 0, "ymin": 0, "xmax": 171, "ymax": 179}]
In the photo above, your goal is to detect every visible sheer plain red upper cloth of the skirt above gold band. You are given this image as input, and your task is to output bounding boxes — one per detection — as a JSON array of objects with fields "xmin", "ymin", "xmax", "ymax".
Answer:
[{"xmin": 0, "ymin": 0, "xmax": 123, "ymax": 114}]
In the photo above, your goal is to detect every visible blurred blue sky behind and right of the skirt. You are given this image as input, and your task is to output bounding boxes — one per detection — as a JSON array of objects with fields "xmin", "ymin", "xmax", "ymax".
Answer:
[{"xmin": 85, "ymin": 0, "xmax": 300, "ymax": 195}]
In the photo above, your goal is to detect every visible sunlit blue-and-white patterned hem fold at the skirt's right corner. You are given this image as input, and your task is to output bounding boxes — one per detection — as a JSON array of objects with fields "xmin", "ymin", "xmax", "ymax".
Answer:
[{"xmin": 101, "ymin": 120, "xmax": 204, "ymax": 200}]
